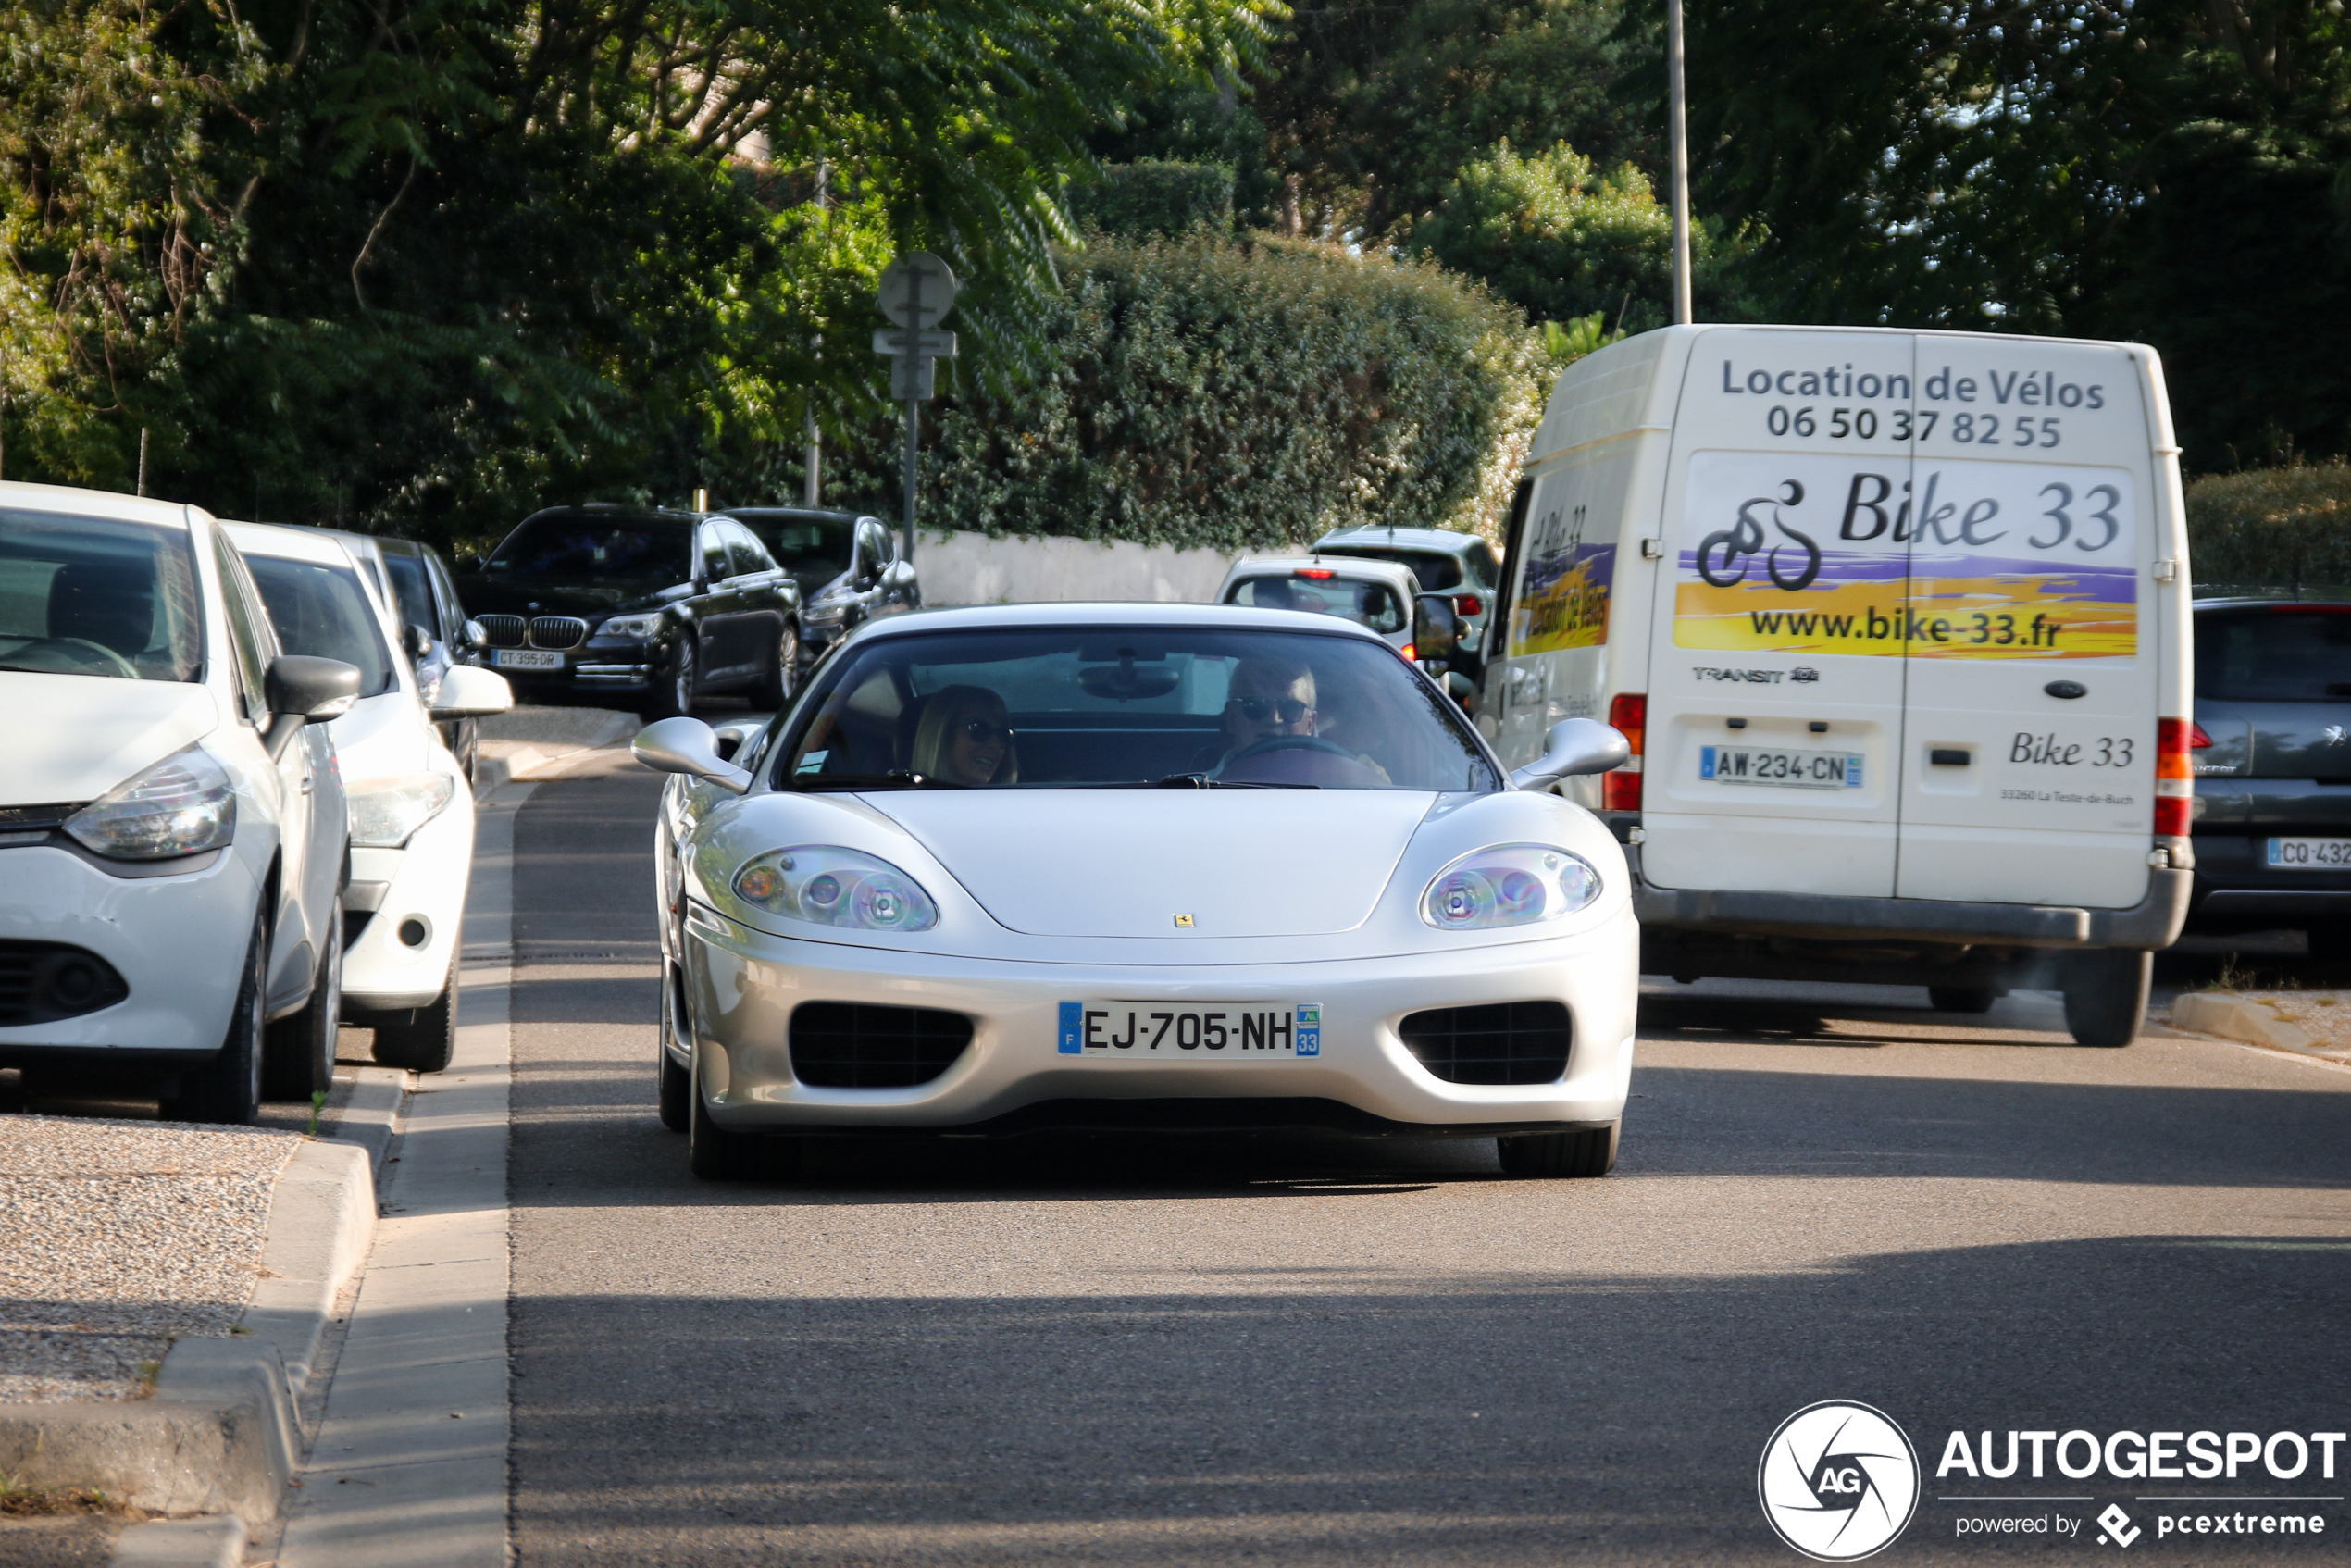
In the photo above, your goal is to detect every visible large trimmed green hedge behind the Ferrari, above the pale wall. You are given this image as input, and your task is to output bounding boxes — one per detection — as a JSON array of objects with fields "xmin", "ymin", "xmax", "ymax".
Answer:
[{"xmin": 921, "ymin": 232, "xmax": 1556, "ymax": 550}]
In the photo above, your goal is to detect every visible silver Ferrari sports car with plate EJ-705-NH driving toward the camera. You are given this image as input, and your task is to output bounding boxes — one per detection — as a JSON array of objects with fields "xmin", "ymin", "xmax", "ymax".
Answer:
[{"xmin": 635, "ymin": 604, "xmax": 1638, "ymax": 1176}]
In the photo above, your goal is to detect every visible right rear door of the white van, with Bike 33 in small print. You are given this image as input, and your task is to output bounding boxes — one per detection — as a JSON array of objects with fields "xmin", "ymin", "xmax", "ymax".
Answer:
[{"xmin": 1895, "ymin": 334, "xmax": 2168, "ymax": 907}]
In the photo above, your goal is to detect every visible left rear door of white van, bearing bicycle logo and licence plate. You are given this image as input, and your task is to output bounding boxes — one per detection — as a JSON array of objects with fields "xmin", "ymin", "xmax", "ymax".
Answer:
[{"xmin": 1641, "ymin": 330, "xmax": 1916, "ymax": 898}]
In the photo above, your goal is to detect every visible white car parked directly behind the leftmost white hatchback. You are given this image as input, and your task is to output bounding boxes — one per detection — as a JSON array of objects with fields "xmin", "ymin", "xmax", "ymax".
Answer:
[{"xmin": 226, "ymin": 522, "xmax": 515, "ymax": 1072}]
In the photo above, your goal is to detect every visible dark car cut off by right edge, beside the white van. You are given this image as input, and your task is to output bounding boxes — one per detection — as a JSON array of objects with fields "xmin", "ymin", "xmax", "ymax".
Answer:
[{"xmin": 2189, "ymin": 600, "xmax": 2351, "ymax": 962}]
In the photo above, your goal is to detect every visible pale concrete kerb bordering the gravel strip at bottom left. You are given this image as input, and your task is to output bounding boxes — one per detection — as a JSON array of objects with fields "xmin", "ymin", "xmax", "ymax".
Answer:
[{"xmin": 0, "ymin": 1123, "xmax": 388, "ymax": 1568}]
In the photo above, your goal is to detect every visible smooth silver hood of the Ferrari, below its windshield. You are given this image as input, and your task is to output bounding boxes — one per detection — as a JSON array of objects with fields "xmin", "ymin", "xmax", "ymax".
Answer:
[{"xmin": 865, "ymin": 790, "xmax": 1434, "ymax": 938}]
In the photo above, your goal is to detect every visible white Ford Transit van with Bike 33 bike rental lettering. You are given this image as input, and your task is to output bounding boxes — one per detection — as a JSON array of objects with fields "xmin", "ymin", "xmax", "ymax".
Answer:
[{"xmin": 1479, "ymin": 327, "xmax": 2194, "ymax": 1046}]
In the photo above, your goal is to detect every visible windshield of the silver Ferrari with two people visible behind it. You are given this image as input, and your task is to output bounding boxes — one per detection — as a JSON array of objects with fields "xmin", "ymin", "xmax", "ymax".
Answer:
[{"xmin": 774, "ymin": 626, "xmax": 1500, "ymax": 790}]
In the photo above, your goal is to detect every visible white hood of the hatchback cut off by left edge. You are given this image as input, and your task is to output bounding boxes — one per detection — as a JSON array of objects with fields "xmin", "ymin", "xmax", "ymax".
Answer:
[{"xmin": 0, "ymin": 670, "xmax": 221, "ymax": 806}]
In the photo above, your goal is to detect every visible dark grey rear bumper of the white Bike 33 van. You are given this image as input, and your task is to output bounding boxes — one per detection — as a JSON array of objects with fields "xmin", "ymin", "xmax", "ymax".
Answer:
[{"xmin": 1624, "ymin": 844, "xmax": 2196, "ymax": 950}]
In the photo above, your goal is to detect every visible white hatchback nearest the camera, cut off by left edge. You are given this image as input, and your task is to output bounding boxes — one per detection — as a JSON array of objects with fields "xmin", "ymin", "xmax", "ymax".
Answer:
[{"xmin": 0, "ymin": 484, "xmax": 357, "ymax": 1124}]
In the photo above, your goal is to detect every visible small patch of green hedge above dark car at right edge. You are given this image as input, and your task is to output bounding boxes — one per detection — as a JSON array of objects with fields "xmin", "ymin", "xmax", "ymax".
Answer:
[{"xmin": 2186, "ymin": 458, "xmax": 2351, "ymax": 595}]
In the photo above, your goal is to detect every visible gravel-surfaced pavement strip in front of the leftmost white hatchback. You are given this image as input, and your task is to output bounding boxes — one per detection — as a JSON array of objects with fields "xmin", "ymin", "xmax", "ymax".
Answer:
[{"xmin": 0, "ymin": 1116, "xmax": 301, "ymax": 1401}]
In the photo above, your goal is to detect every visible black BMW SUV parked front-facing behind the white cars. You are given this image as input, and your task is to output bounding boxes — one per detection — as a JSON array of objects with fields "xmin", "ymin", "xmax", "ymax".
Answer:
[{"xmin": 463, "ymin": 505, "xmax": 800, "ymax": 719}]
